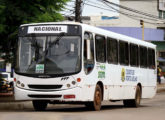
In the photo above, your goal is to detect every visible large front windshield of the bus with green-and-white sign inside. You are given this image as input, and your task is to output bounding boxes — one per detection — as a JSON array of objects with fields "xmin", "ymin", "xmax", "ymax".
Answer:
[{"xmin": 16, "ymin": 36, "xmax": 81, "ymax": 75}]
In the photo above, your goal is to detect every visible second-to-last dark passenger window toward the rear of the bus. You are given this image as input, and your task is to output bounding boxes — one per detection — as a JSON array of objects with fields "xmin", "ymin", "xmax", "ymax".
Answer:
[{"xmin": 140, "ymin": 46, "xmax": 147, "ymax": 68}]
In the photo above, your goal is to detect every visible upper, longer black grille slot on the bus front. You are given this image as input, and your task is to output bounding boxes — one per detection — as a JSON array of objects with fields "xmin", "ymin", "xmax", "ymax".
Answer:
[{"xmin": 28, "ymin": 85, "xmax": 62, "ymax": 89}]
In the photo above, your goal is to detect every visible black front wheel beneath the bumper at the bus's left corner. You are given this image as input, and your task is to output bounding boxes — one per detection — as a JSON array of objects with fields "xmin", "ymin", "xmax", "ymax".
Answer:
[{"xmin": 33, "ymin": 100, "xmax": 48, "ymax": 111}]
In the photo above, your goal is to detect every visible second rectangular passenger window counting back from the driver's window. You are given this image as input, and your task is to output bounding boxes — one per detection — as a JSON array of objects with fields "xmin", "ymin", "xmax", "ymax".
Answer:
[{"xmin": 107, "ymin": 38, "xmax": 118, "ymax": 64}]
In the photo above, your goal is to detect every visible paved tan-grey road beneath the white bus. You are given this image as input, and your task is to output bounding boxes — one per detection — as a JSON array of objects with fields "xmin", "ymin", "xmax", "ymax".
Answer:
[{"xmin": 0, "ymin": 92, "xmax": 165, "ymax": 120}]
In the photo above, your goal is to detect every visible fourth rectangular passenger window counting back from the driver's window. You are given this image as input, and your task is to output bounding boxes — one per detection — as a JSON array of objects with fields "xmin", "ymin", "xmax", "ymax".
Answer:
[{"xmin": 130, "ymin": 44, "xmax": 139, "ymax": 66}]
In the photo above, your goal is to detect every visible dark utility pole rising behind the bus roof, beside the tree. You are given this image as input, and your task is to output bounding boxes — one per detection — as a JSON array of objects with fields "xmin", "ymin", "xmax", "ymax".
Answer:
[{"xmin": 75, "ymin": 0, "xmax": 82, "ymax": 22}]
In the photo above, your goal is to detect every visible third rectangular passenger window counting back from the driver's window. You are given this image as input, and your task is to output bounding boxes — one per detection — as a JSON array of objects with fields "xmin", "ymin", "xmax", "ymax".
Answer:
[{"xmin": 119, "ymin": 41, "xmax": 129, "ymax": 65}]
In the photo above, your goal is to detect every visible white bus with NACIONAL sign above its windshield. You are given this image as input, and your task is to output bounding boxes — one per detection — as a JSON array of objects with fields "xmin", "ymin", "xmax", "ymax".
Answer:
[{"xmin": 14, "ymin": 22, "xmax": 157, "ymax": 110}]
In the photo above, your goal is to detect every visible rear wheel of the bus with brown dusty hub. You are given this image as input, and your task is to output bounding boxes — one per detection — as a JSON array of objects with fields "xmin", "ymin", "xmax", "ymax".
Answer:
[{"xmin": 123, "ymin": 86, "xmax": 141, "ymax": 107}]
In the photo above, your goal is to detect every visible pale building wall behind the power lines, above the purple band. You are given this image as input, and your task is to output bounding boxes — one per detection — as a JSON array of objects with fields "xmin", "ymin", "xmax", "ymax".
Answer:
[{"xmin": 119, "ymin": 0, "xmax": 158, "ymax": 28}]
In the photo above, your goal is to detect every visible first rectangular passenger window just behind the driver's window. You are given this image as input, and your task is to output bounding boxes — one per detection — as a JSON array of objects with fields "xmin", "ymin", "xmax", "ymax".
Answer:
[{"xmin": 95, "ymin": 35, "xmax": 106, "ymax": 63}]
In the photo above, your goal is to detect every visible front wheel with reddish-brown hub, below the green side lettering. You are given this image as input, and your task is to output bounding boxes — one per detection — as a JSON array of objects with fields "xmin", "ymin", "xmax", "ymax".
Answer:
[{"xmin": 85, "ymin": 85, "xmax": 102, "ymax": 111}]
